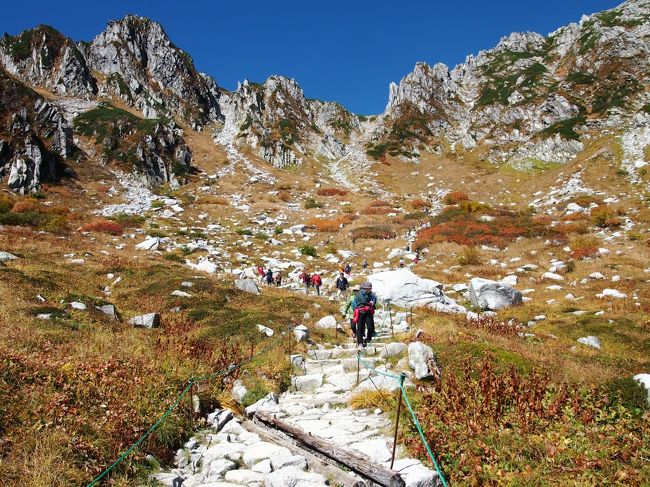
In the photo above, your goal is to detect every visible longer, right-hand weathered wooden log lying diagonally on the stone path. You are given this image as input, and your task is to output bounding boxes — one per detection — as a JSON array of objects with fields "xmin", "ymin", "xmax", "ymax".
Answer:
[{"xmin": 254, "ymin": 411, "xmax": 405, "ymax": 487}]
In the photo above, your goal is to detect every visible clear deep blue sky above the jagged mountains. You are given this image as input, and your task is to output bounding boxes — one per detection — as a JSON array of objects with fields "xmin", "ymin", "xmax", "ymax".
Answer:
[{"xmin": 0, "ymin": 0, "xmax": 620, "ymax": 114}]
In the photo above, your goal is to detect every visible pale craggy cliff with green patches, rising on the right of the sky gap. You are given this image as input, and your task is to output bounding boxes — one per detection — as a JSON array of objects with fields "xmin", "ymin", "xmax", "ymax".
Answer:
[{"xmin": 368, "ymin": 0, "xmax": 650, "ymax": 162}]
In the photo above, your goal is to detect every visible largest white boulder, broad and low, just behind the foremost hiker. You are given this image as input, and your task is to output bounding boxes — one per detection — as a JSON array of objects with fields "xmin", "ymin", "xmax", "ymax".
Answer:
[{"xmin": 368, "ymin": 269, "xmax": 467, "ymax": 313}]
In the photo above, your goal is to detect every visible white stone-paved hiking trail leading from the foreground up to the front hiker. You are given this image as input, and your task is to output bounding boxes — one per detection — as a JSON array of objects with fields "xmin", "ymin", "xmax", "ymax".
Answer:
[{"xmin": 152, "ymin": 310, "xmax": 444, "ymax": 487}]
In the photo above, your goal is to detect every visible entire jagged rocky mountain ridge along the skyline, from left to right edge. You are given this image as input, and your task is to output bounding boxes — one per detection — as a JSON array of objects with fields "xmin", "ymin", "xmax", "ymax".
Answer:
[{"xmin": 0, "ymin": 0, "xmax": 650, "ymax": 193}]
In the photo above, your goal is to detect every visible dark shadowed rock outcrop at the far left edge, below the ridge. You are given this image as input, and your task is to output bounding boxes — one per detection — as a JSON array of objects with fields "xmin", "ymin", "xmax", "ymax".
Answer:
[{"xmin": 0, "ymin": 69, "xmax": 74, "ymax": 193}]
